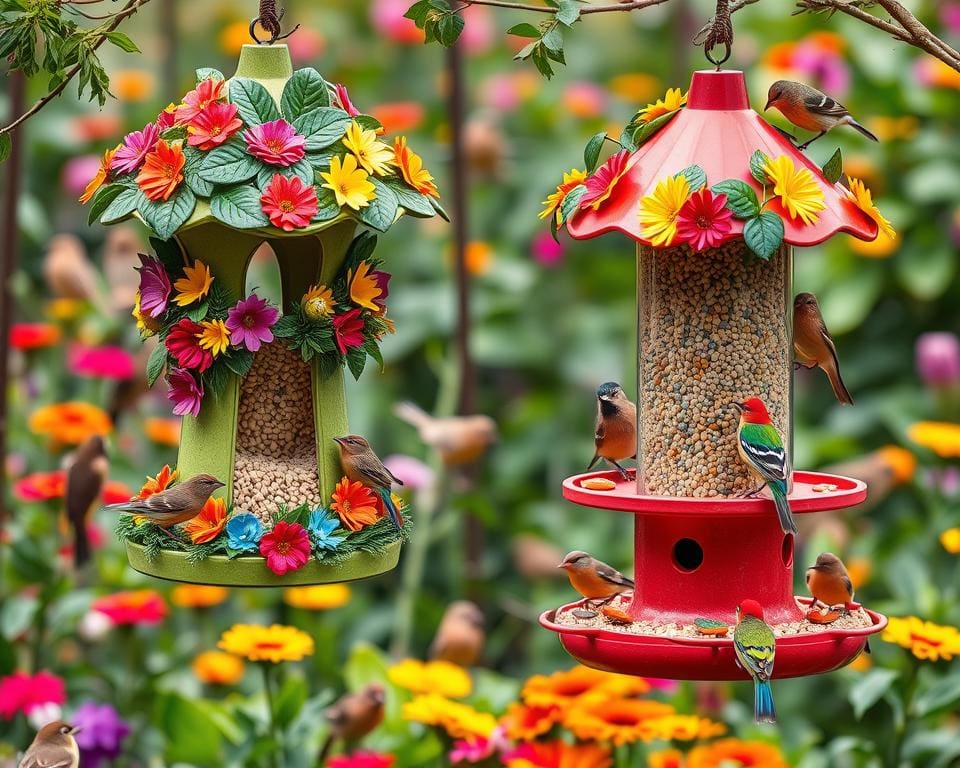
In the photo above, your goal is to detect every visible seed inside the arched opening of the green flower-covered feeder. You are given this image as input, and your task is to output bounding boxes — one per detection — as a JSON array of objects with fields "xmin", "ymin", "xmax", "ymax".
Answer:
[{"xmin": 233, "ymin": 341, "xmax": 322, "ymax": 522}]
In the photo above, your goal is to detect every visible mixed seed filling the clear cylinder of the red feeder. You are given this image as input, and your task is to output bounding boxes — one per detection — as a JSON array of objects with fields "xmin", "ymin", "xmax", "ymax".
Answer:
[{"xmin": 638, "ymin": 240, "xmax": 793, "ymax": 498}]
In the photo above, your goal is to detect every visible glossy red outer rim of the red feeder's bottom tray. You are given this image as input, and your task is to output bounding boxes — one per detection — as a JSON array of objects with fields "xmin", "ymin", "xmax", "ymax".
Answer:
[{"xmin": 540, "ymin": 601, "xmax": 887, "ymax": 680}]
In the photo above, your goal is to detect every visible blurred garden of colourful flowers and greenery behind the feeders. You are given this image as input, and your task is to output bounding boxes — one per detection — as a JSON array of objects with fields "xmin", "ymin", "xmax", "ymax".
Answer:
[{"xmin": 0, "ymin": 0, "xmax": 960, "ymax": 768}]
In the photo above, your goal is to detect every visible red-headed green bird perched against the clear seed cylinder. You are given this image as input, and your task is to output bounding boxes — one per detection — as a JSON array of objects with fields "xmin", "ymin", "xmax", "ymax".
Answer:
[{"xmin": 733, "ymin": 397, "xmax": 797, "ymax": 533}]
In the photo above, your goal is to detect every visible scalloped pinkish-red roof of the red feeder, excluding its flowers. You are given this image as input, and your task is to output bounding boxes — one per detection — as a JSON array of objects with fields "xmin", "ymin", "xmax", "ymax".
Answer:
[{"xmin": 567, "ymin": 70, "xmax": 877, "ymax": 246}]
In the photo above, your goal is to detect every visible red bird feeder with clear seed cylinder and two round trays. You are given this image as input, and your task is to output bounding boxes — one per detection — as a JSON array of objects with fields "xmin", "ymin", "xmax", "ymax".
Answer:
[{"xmin": 541, "ymin": 70, "xmax": 886, "ymax": 680}]
